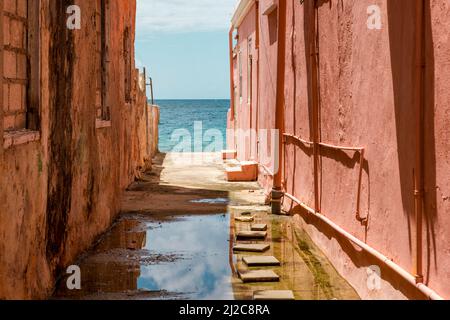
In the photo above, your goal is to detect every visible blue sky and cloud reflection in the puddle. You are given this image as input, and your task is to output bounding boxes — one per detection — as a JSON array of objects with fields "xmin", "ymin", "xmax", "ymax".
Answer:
[{"xmin": 138, "ymin": 215, "xmax": 232, "ymax": 299}]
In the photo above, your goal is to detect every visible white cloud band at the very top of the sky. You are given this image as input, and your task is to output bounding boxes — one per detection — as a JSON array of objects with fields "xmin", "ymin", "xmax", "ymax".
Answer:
[{"xmin": 137, "ymin": 0, "xmax": 237, "ymax": 36}]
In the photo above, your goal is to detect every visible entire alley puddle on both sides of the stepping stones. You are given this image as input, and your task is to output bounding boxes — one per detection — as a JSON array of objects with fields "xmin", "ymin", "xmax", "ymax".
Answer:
[{"xmin": 54, "ymin": 209, "xmax": 358, "ymax": 300}]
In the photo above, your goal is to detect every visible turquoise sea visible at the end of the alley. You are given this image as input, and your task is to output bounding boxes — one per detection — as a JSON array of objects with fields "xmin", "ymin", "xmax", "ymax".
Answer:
[{"xmin": 155, "ymin": 100, "xmax": 230, "ymax": 152}]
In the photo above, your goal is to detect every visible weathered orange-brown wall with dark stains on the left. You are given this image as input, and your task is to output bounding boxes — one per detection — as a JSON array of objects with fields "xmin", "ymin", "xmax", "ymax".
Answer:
[{"xmin": 0, "ymin": 0, "xmax": 158, "ymax": 299}]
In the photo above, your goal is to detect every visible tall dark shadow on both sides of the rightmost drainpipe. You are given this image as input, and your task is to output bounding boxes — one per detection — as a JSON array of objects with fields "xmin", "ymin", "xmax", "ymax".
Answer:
[{"xmin": 387, "ymin": 0, "xmax": 437, "ymax": 283}]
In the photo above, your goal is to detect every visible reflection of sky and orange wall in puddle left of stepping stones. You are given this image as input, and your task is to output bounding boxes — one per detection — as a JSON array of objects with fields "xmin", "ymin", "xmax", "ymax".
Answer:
[{"xmin": 55, "ymin": 214, "xmax": 233, "ymax": 299}]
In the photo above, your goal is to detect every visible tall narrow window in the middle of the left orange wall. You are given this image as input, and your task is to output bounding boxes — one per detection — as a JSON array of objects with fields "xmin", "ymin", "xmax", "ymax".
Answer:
[{"xmin": 96, "ymin": 0, "xmax": 111, "ymax": 121}]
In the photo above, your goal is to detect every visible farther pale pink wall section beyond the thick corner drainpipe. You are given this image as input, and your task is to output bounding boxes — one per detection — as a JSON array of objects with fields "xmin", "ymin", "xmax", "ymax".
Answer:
[{"xmin": 227, "ymin": 0, "xmax": 278, "ymax": 196}]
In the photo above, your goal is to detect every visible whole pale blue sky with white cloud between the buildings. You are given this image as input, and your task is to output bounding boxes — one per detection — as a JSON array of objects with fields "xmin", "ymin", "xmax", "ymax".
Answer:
[{"xmin": 136, "ymin": 0, "xmax": 236, "ymax": 99}]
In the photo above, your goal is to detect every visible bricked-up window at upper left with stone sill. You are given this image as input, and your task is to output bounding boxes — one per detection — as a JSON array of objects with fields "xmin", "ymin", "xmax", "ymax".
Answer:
[{"xmin": 2, "ymin": 0, "xmax": 40, "ymax": 133}]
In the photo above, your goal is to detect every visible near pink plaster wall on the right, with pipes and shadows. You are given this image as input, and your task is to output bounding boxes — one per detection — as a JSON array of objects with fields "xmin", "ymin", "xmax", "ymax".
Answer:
[{"xmin": 230, "ymin": 0, "xmax": 450, "ymax": 298}]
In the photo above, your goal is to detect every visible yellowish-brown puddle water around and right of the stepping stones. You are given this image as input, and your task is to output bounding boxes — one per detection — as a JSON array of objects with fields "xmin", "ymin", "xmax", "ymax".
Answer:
[{"xmin": 233, "ymin": 213, "xmax": 359, "ymax": 300}]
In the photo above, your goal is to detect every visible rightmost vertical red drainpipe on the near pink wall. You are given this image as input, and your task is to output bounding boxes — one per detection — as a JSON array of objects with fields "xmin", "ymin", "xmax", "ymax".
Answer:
[{"xmin": 414, "ymin": 0, "xmax": 426, "ymax": 283}]
